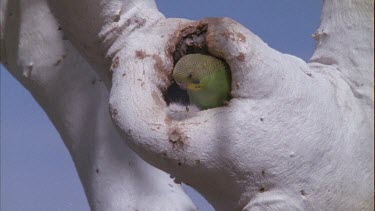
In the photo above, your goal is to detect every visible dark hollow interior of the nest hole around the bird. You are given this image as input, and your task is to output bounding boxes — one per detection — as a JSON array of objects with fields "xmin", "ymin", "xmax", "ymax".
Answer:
[{"xmin": 164, "ymin": 24, "xmax": 229, "ymax": 106}]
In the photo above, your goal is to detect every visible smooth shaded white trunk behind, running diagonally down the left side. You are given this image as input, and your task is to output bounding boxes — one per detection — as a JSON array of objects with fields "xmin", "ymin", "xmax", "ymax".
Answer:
[{"xmin": 1, "ymin": 0, "xmax": 195, "ymax": 210}]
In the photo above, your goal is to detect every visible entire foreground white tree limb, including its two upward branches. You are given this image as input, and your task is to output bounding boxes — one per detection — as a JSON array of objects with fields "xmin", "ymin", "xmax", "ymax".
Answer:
[{"xmin": 1, "ymin": 0, "xmax": 374, "ymax": 210}]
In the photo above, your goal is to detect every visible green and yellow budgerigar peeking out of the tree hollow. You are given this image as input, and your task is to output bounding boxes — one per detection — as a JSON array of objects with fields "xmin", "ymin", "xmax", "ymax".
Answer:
[{"xmin": 173, "ymin": 54, "xmax": 231, "ymax": 110}]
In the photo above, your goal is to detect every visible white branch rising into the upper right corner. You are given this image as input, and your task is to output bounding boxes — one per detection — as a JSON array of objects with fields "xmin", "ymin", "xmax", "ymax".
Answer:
[{"xmin": 310, "ymin": 0, "xmax": 374, "ymax": 104}]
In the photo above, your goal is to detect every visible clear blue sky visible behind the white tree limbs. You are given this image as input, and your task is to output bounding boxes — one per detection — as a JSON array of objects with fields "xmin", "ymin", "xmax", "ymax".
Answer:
[{"xmin": 0, "ymin": 0, "xmax": 322, "ymax": 211}]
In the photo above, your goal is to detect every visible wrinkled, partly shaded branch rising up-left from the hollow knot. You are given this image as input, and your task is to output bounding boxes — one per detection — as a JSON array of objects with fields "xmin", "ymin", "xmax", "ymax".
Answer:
[{"xmin": 48, "ymin": 0, "xmax": 164, "ymax": 87}]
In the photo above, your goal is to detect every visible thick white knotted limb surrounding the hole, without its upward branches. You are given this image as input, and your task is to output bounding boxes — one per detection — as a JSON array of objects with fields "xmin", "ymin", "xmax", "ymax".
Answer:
[{"xmin": 106, "ymin": 2, "xmax": 373, "ymax": 210}]
